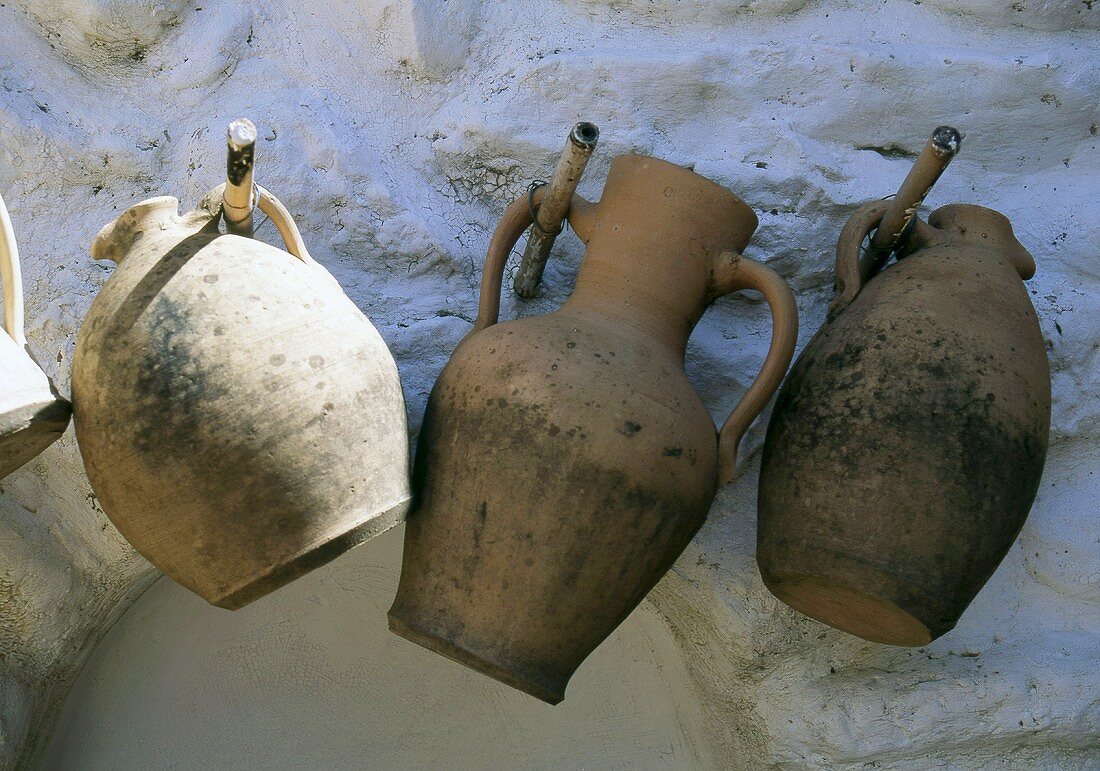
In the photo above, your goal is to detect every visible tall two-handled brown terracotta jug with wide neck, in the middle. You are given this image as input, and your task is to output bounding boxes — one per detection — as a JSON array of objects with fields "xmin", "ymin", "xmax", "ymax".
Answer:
[{"xmin": 389, "ymin": 155, "xmax": 798, "ymax": 704}]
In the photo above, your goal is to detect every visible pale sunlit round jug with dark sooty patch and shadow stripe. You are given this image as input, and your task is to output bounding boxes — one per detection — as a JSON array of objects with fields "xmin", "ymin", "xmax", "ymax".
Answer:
[{"xmin": 73, "ymin": 186, "xmax": 411, "ymax": 608}]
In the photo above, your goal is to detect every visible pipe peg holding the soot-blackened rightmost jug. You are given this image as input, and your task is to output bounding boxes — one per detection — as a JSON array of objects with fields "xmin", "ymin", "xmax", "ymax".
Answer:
[{"xmin": 860, "ymin": 125, "xmax": 963, "ymax": 278}]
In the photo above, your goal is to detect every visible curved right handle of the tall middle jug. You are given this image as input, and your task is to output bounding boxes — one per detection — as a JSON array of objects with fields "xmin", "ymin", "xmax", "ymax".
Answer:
[{"xmin": 715, "ymin": 252, "xmax": 799, "ymax": 485}]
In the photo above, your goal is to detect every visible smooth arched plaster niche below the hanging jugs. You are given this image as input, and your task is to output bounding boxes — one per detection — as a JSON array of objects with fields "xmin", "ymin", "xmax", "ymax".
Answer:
[{"xmin": 43, "ymin": 529, "xmax": 717, "ymax": 770}]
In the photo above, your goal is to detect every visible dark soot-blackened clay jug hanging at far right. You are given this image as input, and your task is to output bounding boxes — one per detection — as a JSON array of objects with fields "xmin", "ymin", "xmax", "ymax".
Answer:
[{"xmin": 757, "ymin": 203, "xmax": 1051, "ymax": 646}]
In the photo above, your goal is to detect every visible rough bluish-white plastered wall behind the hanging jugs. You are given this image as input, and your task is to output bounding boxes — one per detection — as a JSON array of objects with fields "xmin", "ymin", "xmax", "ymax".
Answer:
[{"xmin": 0, "ymin": 0, "xmax": 1100, "ymax": 768}]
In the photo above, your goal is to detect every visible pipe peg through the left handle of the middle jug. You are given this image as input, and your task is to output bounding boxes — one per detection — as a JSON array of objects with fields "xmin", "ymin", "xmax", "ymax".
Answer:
[{"xmin": 512, "ymin": 122, "xmax": 600, "ymax": 299}]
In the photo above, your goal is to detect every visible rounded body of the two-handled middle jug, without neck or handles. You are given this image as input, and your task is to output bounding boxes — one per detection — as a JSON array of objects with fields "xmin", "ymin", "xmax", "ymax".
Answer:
[{"xmin": 391, "ymin": 311, "xmax": 717, "ymax": 703}]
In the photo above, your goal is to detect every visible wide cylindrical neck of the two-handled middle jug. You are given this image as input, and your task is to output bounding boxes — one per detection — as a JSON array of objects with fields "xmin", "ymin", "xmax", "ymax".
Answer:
[{"xmin": 565, "ymin": 155, "xmax": 757, "ymax": 362}]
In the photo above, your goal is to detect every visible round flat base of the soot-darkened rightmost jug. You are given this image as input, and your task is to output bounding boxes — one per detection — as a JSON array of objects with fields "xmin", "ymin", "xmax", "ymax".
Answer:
[{"xmin": 757, "ymin": 542, "xmax": 955, "ymax": 648}]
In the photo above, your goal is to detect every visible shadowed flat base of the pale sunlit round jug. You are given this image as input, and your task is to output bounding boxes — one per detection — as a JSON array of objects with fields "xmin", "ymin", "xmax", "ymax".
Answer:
[{"xmin": 204, "ymin": 498, "xmax": 411, "ymax": 610}]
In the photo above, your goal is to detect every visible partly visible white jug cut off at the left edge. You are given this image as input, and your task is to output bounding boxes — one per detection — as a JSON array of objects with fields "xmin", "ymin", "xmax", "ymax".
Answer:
[{"xmin": 0, "ymin": 192, "xmax": 73, "ymax": 478}]
